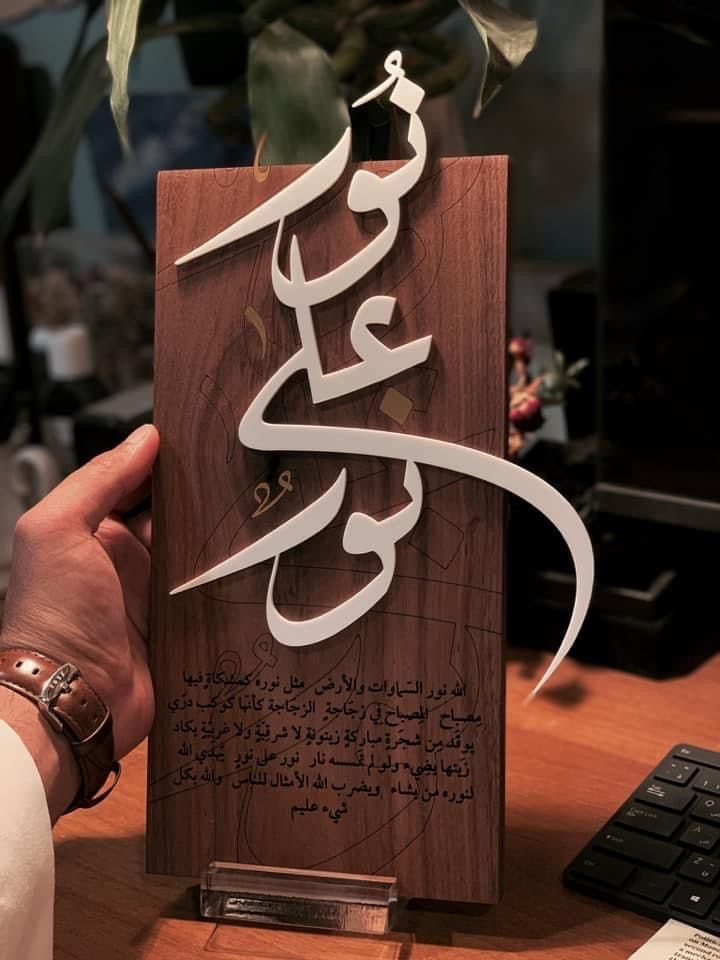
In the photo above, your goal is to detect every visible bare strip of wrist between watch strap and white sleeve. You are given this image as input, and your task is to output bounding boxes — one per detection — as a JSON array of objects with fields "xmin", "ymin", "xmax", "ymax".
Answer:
[{"xmin": 0, "ymin": 687, "xmax": 80, "ymax": 823}]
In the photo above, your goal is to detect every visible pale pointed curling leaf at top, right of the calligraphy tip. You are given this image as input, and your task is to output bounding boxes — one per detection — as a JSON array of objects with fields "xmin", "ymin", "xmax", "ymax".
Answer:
[{"xmin": 458, "ymin": 0, "xmax": 537, "ymax": 117}]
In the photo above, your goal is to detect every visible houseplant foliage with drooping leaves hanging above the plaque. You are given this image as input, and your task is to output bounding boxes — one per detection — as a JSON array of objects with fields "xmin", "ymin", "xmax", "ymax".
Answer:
[{"xmin": 0, "ymin": 0, "xmax": 537, "ymax": 233}]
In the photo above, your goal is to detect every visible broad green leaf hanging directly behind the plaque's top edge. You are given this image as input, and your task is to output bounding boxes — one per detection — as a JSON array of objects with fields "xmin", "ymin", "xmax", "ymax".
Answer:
[{"xmin": 248, "ymin": 20, "xmax": 350, "ymax": 163}]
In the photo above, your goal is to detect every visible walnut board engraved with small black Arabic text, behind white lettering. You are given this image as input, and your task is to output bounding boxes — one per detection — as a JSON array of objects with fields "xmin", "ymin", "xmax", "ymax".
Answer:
[{"xmin": 147, "ymin": 157, "xmax": 507, "ymax": 903}]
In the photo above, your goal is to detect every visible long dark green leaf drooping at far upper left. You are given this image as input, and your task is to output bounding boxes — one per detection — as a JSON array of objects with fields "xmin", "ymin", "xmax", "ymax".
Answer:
[{"xmin": 0, "ymin": 40, "xmax": 109, "ymax": 236}]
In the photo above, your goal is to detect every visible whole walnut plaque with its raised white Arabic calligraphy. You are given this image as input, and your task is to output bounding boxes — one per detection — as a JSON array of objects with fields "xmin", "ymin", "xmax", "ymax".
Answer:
[{"xmin": 147, "ymin": 51, "xmax": 593, "ymax": 925}]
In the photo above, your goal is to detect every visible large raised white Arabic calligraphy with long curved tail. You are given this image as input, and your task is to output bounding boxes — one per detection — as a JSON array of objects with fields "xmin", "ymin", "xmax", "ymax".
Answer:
[{"xmin": 171, "ymin": 51, "xmax": 594, "ymax": 695}]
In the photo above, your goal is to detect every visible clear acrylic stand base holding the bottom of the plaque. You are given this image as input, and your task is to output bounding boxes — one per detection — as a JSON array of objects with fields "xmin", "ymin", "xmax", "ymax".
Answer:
[{"xmin": 200, "ymin": 861, "xmax": 397, "ymax": 934}]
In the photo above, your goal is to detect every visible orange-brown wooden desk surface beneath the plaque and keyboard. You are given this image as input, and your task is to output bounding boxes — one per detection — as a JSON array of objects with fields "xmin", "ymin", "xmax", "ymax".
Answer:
[{"xmin": 56, "ymin": 654, "xmax": 720, "ymax": 960}]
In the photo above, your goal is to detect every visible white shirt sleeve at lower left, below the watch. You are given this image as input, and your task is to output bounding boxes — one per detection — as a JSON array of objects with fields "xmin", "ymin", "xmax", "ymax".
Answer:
[{"xmin": 0, "ymin": 720, "xmax": 55, "ymax": 960}]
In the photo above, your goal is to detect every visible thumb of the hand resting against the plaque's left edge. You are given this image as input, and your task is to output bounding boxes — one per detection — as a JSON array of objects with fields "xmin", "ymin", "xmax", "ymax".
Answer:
[{"xmin": 42, "ymin": 423, "xmax": 160, "ymax": 533}]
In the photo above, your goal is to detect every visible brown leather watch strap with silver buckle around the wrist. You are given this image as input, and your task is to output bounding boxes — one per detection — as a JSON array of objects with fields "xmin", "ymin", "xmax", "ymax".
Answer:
[{"xmin": 0, "ymin": 647, "xmax": 120, "ymax": 813}]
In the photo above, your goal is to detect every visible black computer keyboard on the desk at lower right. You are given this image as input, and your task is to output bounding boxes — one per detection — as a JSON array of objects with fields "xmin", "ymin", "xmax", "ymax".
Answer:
[{"xmin": 563, "ymin": 743, "xmax": 720, "ymax": 935}]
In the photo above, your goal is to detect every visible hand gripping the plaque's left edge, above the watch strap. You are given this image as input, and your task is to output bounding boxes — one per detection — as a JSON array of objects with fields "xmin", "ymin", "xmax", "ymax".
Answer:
[{"xmin": 0, "ymin": 425, "xmax": 158, "ymax": 780}]
